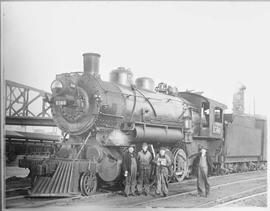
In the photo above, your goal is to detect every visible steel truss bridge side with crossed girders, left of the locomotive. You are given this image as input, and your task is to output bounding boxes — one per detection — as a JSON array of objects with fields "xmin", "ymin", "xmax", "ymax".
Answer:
[{"xmin": 5, "ymin": 80, "xmax": 56, "ymax": 126}]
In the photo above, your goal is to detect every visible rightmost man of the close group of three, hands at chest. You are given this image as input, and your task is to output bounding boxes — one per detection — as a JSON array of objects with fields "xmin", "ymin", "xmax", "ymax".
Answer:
[{"xmin": 155, "ymin": 147, "xmax": 171, "ymax": 197}]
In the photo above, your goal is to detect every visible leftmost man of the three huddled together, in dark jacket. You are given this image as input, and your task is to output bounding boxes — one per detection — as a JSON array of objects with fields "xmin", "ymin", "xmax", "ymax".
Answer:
[{"xmin": 123, "ymin": 145, "xmax": 137, "ymax": 197}]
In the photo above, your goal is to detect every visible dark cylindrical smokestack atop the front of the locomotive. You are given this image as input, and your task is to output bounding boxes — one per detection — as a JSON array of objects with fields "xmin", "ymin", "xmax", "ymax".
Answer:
[{"xmin": 83, "ymin": 53, "xmax": 100, "ymax": 76}]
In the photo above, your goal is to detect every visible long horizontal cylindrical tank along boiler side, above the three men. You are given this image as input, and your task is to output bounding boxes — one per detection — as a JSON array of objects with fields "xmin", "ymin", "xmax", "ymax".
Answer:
[{"xmin": 133, "ymin": 126, "xmax": 184, "ymax": 144}]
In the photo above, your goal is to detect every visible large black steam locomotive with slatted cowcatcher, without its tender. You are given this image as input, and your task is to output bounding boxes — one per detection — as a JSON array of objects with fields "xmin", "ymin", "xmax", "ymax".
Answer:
[{"xmin": 27, "ymin": 53, "xmax": 263, "ymax": 196}]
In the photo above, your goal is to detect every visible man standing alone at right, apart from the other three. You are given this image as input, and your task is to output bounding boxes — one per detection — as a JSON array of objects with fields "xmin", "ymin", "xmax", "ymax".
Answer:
[{"xmin": 193, "ymin": 146, "xmax": 212, "ymax": 197}]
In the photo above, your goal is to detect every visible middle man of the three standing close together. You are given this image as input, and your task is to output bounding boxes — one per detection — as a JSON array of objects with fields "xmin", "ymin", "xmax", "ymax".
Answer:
[{"xmin": 137, "ymin": 143, "xmax": 152, "ymax": 196}]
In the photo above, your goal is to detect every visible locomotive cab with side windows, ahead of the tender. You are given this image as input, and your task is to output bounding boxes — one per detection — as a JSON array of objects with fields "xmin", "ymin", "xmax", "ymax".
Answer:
[{"xmin": 179, "ymin": 92, "xmax": 227, "ymax": 176}]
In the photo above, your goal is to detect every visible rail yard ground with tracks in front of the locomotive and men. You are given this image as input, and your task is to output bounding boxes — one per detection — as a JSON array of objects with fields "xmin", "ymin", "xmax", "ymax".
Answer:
[{"xmin": 7, "ymin": 171, "xmax": 267, "ymax": 210}]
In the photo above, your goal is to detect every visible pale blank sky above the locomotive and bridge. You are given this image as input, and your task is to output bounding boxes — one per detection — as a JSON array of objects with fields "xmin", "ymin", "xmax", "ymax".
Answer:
[{"xmin": 1, "ymin": 1, "xmax": 270, "ymax": 119}]
